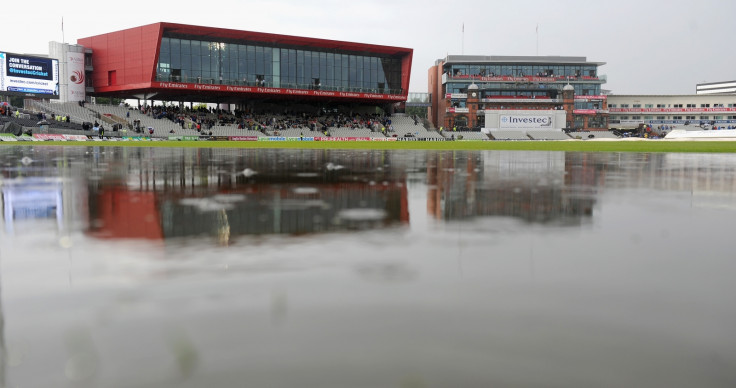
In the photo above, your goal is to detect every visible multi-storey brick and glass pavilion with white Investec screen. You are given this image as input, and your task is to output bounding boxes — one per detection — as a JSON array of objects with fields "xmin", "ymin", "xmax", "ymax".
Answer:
[{"xmin": 428, "ymin": 55, "xmax": 608, "ymax": 131}]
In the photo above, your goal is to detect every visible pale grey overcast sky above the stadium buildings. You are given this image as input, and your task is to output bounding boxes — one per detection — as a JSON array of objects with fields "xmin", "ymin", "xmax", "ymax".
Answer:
[{"xmin": 0, "ymin": 0, "xmax": 736, "ymax": 94}]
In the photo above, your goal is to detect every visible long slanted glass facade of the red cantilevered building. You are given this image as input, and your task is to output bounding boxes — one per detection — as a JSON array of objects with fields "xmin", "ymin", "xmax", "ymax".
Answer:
[{"xmin": 156, "ymin": 37, "xmax": 403, "ymax": 94}]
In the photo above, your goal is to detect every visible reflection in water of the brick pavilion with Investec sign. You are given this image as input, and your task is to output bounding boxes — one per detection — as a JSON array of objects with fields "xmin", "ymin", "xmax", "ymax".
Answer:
[{"xmin": 427, "ymin": 152, "xmax": 600, "ymax": 225}]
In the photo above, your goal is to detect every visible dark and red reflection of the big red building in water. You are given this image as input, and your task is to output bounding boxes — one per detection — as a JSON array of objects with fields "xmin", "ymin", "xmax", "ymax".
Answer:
[{"xmin": 89, "ymin": 149, "xmax": 409, "ymax": 240}]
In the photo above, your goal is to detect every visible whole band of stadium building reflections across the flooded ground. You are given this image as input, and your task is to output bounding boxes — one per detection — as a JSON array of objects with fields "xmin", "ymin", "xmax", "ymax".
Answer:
[{"xmin": 1, "ymin": 147, "xmax": 735, "ymax": 240}]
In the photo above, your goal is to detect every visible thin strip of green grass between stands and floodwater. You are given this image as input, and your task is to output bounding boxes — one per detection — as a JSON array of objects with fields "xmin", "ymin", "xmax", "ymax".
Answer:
[{"xmin": 0, "ymin": 140, "xmax": 736, "ymax": 153}]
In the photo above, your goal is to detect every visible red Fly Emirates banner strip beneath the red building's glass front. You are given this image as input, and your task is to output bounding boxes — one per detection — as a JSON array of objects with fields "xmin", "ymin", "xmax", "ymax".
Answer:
[{"xmin": 151, "ymin": 82, "xmax": 406, "ymax": 101}]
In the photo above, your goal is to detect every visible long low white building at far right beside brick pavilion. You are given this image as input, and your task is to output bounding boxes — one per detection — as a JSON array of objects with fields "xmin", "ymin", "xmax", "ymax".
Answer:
[{"xmin": 608, "ymin": 94, "xmax": 736, "ymax": 129}]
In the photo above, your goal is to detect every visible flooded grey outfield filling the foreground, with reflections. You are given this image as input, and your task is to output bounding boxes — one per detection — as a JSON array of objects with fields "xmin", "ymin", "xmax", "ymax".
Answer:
[{"xmin": 0, "ymin": 146, "xmax": 736, "ymax": 388}]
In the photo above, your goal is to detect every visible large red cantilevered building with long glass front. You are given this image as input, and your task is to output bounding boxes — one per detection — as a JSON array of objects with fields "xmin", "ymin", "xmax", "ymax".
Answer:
[{"xmin": 77, "ymin": 23, "xmax": 413, "ymax": 105}]
